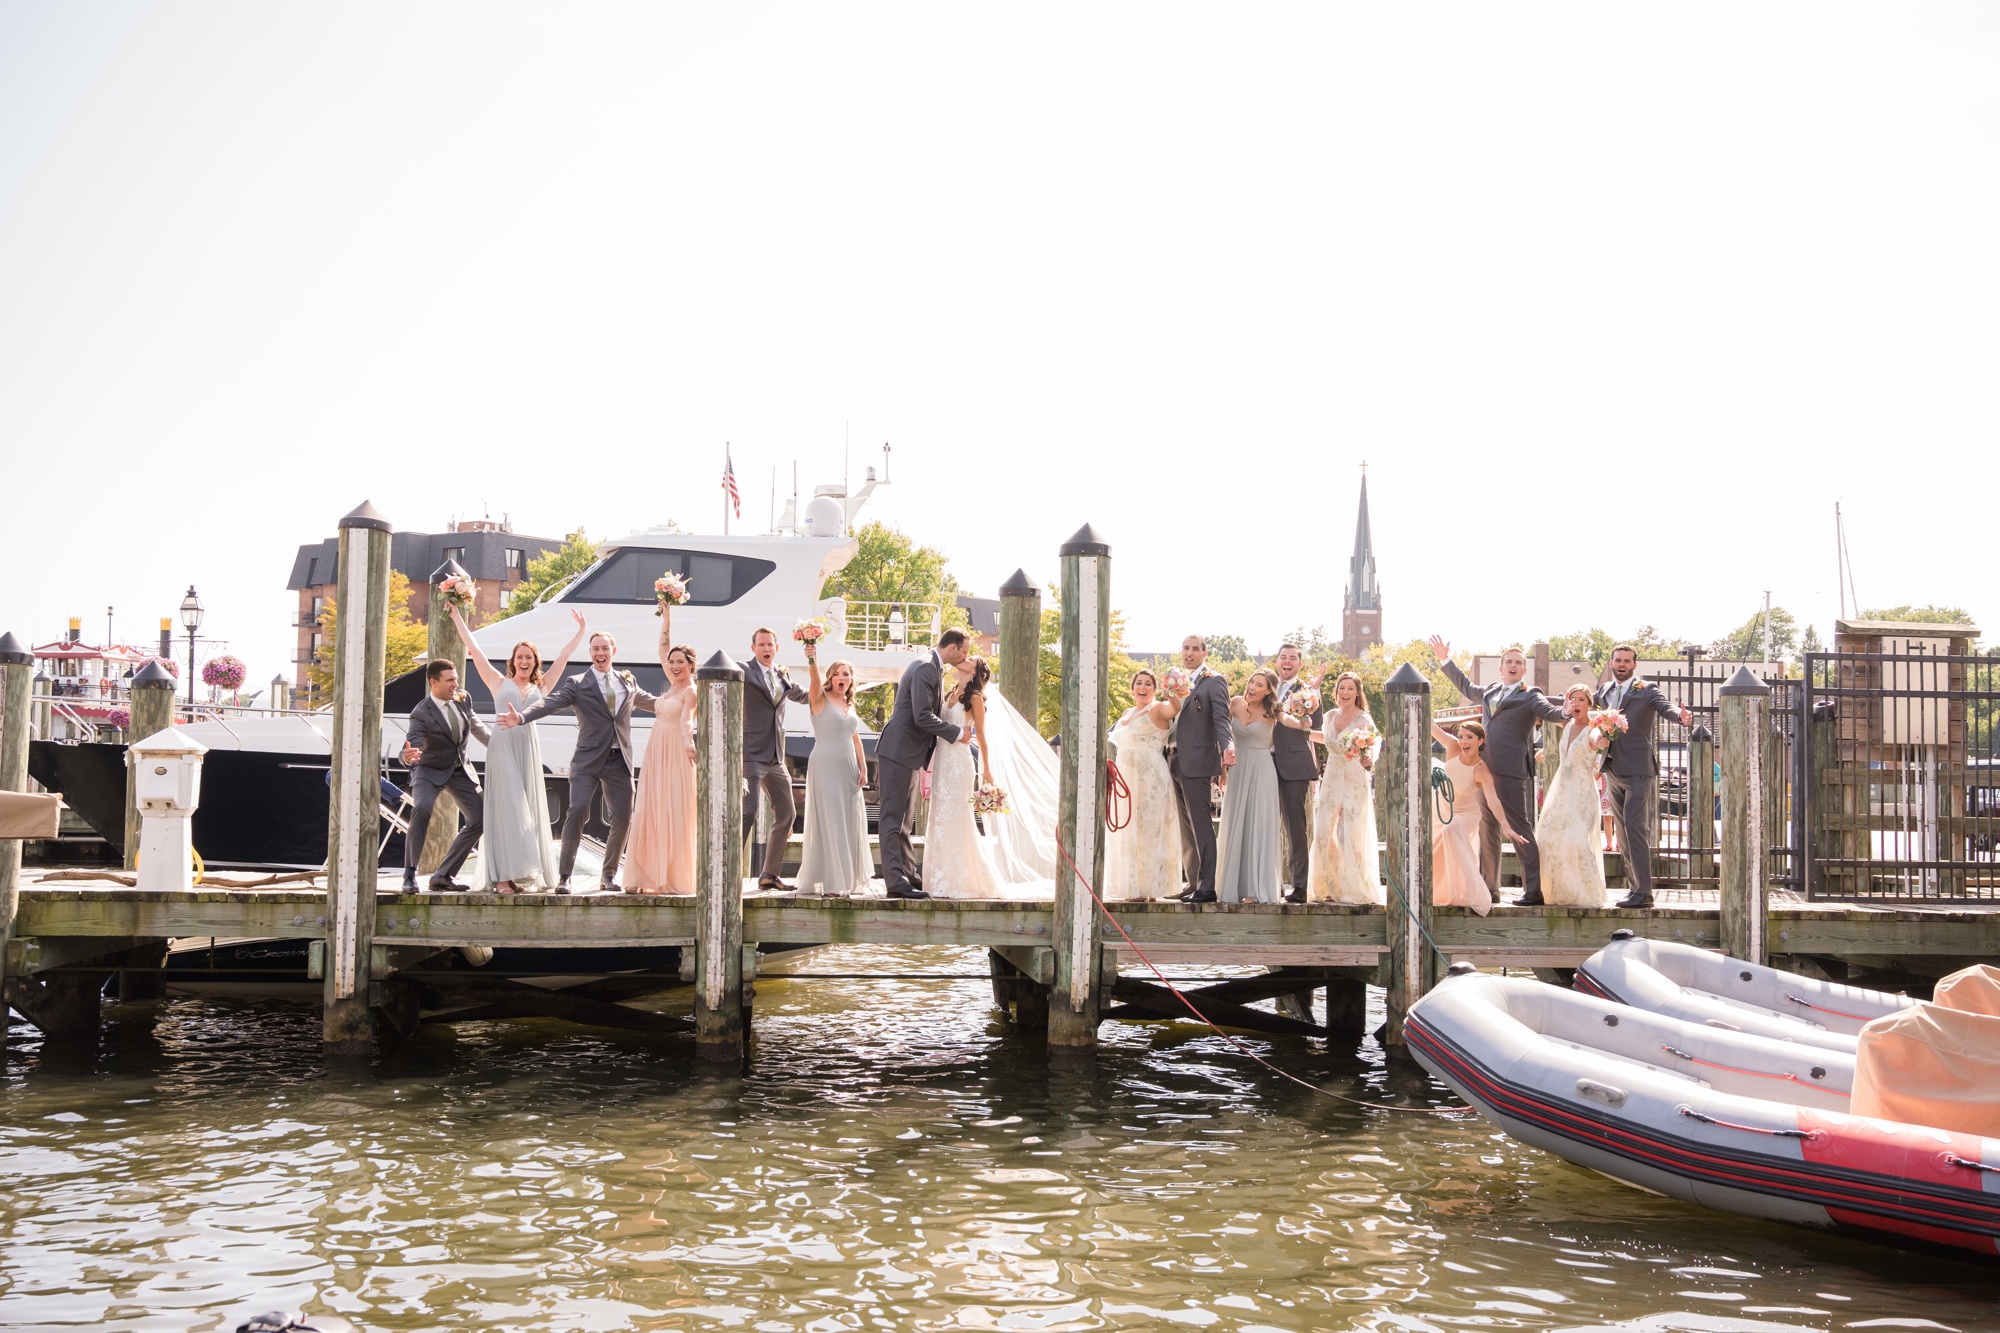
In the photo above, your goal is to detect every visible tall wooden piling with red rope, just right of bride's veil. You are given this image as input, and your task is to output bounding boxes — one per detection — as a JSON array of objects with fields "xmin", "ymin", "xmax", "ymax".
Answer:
[{"xmin": 1048, "ymin": 522, "xmax": 1112, "ymax": 1051}]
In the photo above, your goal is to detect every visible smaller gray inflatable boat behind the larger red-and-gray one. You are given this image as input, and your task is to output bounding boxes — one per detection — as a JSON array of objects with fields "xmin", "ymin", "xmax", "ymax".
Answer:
[{"xmin": 1576, "ymin": 931, "xmax": 1916, "ymax": 1053}]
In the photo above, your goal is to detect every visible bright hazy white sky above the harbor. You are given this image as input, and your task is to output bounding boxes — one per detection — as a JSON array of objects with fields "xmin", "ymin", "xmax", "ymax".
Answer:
[{"xmin": 0, "ymin": 0, "xmax": 2000, "ymax": 681}]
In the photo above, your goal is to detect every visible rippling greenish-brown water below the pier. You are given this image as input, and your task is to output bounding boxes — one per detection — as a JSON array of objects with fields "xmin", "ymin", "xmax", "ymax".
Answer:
[{"xmin": 0, "ymin": 947, "xmax": 2000, "ymax": 1333}]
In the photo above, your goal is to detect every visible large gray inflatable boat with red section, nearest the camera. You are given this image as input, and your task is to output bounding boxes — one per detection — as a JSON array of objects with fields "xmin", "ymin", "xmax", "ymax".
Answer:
[{"xmin": 1404, "ymin": 959, "xmax": 2000, "ymax": 1261}]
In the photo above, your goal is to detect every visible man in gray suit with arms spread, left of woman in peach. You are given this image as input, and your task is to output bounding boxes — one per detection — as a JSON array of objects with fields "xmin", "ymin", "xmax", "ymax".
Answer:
[{"xmin": 500, "ymin": 630, "xmax": 660, "ymax": 893}]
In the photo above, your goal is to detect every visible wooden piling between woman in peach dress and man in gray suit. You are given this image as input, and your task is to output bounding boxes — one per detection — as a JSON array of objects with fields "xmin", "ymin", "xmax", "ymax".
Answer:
[{"xmin": 694, "ymin": 648, "xmax": 748, "ymax": 1063}]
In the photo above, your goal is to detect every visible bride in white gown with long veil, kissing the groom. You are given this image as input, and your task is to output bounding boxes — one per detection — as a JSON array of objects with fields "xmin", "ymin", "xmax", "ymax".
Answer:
[{"xmin": 924, "ymin": 656, "xmax": 1058, "ymax": 899}]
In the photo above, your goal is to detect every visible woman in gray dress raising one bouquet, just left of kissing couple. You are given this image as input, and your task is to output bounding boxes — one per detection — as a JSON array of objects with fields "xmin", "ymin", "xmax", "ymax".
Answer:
[{"xmin": 798, "ymin": 642, "xmax": 874, "ymax": 897}]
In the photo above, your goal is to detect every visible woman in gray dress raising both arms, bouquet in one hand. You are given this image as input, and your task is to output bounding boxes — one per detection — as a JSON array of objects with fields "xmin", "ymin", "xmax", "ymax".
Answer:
[{"xmin": 450, "ymin": 606, "xmax": 586, "ymax": 893}]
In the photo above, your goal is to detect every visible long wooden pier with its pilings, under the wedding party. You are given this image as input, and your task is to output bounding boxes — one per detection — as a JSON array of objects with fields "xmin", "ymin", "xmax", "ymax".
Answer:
[{"xmin": 0, "ymin": 504, "xmax": 2000, "ymax": 1065}]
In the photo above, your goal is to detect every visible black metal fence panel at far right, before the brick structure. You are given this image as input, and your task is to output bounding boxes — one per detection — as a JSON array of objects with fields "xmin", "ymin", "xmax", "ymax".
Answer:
[{"xmin": 1796, "ymin": 650, "xmax": 2000, "ymax": 901}]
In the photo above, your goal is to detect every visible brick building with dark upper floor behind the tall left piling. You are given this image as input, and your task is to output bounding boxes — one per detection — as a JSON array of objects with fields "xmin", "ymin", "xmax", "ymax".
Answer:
[{"xmin": 284, "ymin": 518, "xmax": 562, "ymax": 689}]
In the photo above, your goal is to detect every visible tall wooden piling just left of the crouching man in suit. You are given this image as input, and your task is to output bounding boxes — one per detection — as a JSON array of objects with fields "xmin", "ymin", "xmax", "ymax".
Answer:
[{"xmin": 322, "ymin": 502, "xmax": 390, "ymax": 1059}]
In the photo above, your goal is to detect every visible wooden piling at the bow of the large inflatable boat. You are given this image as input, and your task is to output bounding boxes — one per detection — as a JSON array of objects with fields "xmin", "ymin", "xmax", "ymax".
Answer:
[{"xmin": 1374, "ymin": 662, "xmax": 1438, "ymax": 1047}]
